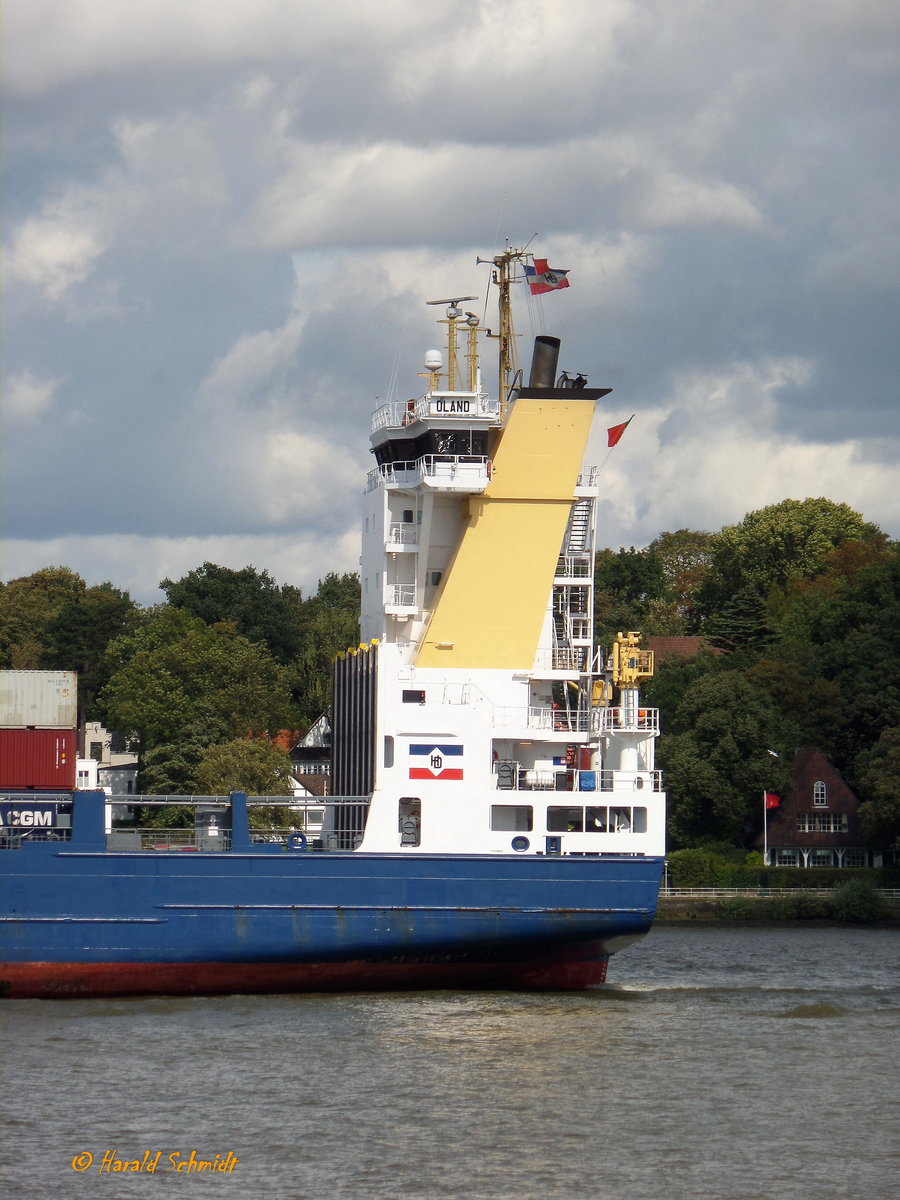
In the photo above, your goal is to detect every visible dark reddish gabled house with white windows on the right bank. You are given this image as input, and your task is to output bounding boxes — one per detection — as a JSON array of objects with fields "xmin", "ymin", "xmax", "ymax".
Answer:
[{"xmin": 757, "ymin": 749, "xmax": 871, "ymax": 866}]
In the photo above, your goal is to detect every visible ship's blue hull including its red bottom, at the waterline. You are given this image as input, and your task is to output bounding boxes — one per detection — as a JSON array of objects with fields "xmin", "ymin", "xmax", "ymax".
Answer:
[{"xmin": 0, "ymin": 797, "xmax": 662, "ymax": 997}]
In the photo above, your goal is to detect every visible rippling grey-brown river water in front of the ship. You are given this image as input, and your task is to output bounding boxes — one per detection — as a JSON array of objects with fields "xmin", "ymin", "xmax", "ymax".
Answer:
[{"xmin": 0, "ymin": 925, "xmax": 900, "ymax": 1200}]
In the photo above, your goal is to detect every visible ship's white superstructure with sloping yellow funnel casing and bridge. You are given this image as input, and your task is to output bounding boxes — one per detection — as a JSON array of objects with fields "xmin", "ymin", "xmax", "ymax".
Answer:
[{"xmin": 334, "ymin": 262, "xmax": 665, "ymax": 856}]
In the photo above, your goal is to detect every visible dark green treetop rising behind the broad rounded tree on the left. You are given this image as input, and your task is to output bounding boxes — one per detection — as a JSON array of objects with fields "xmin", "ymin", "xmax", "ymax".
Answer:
[{"xmin": 160, "ymin": 563, "xmax": 302, "ymax": 662}]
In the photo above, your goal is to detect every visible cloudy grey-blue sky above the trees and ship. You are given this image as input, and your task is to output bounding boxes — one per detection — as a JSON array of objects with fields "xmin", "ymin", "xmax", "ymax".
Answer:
[{"xmin": 2, "ymin": 0, "xmax": 900, "ymax": 602}]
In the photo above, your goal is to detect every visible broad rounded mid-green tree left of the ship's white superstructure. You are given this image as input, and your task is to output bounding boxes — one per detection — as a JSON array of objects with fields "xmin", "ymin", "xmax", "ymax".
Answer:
[{"xmin": 100, "ymin": 605, "xmax": 292, "ymax": 754}]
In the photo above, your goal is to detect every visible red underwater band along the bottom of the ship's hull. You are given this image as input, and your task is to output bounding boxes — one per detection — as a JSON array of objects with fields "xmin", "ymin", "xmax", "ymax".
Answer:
[{"xmin": 0, "ymin": 955, "xmax": 608, "ymax": 1000}]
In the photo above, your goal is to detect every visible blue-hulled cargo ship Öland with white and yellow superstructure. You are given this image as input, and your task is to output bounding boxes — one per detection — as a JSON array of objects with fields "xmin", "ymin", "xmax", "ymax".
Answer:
[{"xmin": 0, "ymin": 247, "xmax": 665, "ymax": 998}]
